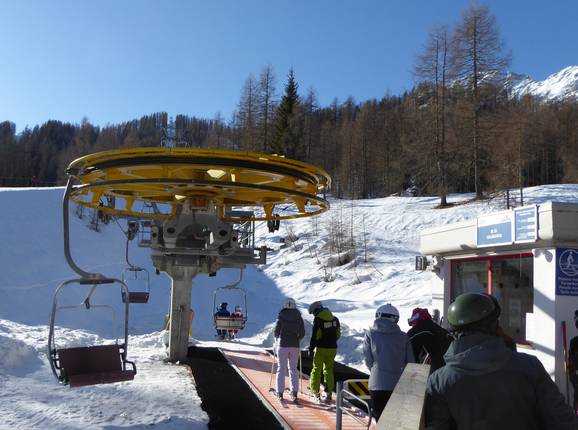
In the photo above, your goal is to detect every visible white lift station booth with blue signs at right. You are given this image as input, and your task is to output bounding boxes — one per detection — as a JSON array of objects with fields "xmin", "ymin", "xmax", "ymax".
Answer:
[{"xmin": 416, "ymin": 202, "xmax": 578, "ymax": 401}]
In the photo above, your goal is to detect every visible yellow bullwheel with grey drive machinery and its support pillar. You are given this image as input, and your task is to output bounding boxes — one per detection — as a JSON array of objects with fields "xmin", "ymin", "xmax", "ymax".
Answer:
[{"xmin": 58, "ymin": 148, "xmax": 331, "ymax": 362}]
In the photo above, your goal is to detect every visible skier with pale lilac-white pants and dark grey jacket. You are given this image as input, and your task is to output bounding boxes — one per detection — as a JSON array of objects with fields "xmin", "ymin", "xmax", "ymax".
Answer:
[{"xmin": 274, "ymin": 298, "xmax": 305, "ymax": 402}]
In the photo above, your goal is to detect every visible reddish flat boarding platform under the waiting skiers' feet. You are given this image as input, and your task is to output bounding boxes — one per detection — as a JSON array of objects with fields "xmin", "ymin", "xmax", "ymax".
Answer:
[{"xmin": 220, "ymin": 349, "xmax": 375, "ymax": 430}]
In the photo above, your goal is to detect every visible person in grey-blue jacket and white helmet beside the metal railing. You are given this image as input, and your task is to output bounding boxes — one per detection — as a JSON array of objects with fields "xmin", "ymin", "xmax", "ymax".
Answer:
[{"xmin": 363, "ymin": 303, "xmax": 415, "ymax": 420}]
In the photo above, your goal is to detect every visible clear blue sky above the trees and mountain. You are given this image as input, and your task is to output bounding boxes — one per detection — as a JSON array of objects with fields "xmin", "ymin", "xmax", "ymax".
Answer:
[{"xmin": 0, "ymin": 0, "xmax": 578, "ymax": 130}]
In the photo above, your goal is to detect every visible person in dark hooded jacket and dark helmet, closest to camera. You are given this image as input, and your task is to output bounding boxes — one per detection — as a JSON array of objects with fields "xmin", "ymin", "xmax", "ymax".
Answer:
[{"xmin": 426, "ymin": 293, "xmax": 578, "ymax": 430}]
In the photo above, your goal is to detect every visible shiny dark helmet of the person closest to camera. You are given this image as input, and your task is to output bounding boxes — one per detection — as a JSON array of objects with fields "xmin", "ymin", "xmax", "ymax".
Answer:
[{"xmin": 448, "ymin": 293, "xmax": 500, "ymax": 331}]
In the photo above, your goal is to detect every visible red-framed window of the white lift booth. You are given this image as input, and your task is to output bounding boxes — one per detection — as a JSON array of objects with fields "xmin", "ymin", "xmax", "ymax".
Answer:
[{"xmin": 452, "ymin": 254, "xmax": 534, "ymax": 343}]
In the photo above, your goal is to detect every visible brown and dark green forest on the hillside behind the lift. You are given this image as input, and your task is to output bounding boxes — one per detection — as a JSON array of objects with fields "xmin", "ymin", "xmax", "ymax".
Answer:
[{"xmin": 0, "ymin": 5, "xmax": 578, "ymax": 205}]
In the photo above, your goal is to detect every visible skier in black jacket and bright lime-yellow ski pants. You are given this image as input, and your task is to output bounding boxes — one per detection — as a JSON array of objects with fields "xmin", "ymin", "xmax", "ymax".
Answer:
[{"xmin": 308, "ymin": 302, "xmax": 341, "ymax": 404}]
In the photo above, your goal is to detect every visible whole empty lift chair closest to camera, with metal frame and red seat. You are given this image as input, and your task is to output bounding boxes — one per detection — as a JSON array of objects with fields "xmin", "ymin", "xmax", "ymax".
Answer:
[{"xmin": 48, "ymin": 278, "xmax": 136, "ymax": 387}]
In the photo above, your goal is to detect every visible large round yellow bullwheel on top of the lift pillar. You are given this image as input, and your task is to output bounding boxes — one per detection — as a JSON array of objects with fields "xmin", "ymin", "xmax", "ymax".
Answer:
[{"xmin": 67, "ymin": 148, "xmax": 331, "ymax": 222}]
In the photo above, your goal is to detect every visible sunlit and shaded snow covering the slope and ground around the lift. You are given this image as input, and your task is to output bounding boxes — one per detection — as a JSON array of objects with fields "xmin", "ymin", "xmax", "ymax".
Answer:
[{"xmin": 0, "ymin": 185, "xmax": 578, "ymax": 429}]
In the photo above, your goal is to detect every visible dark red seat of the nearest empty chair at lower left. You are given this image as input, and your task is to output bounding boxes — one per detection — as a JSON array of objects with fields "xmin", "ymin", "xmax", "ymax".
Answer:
[{"xmin": 55, "ymin": 345, "xmax": 136, "ymax": 387}]
